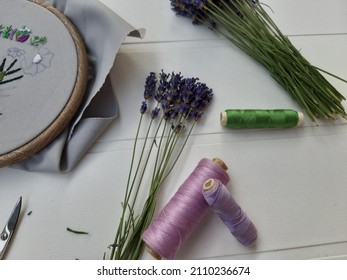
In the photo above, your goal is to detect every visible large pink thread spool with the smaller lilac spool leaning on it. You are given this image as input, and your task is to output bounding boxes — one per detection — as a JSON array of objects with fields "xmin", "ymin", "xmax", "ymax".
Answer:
[{"xmin": 142, "ymin": 159, "xmax": 229, "ymax": 259}]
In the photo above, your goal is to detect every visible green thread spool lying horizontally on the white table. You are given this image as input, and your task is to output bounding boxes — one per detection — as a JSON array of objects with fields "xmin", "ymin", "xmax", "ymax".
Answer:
[{"xmin": 220, "ymin": 109, "xmax": 304, "ymax": 129}]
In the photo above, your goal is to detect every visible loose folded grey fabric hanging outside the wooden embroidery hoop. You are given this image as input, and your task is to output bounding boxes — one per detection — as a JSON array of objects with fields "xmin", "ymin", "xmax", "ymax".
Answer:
[{"xmin": 11, "ymin": 0, "xmax": 142, "ymax": 172}]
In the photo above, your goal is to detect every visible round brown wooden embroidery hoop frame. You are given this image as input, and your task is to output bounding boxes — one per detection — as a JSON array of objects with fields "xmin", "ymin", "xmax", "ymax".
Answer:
[{"xmin": 0, "ymin": 0, "xmax": 88, "ymax": 167}]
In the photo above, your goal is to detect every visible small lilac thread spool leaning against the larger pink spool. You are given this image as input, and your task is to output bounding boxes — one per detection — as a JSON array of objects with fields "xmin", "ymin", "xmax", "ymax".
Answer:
[{"xmin": 202, "ymin": 179, "xmax": 257, "ymax": 246}]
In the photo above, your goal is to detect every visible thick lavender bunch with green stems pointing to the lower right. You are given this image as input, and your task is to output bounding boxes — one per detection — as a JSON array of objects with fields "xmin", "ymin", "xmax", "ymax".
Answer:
[{"xmin": 170, "ymin": 0, "xmax": 347, "ymax": 122}]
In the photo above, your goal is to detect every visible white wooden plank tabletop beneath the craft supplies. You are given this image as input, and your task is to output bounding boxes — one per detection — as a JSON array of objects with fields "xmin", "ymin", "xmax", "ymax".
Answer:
[{"xmin": 0, "ymin": 0, "xmax": 347, "ymax": 259}]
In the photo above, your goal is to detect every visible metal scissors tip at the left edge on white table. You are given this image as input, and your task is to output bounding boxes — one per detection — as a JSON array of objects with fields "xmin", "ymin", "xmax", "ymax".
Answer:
[{"xmin": 0, "ymin": 197, "xmax": 22, "ymax": 260}]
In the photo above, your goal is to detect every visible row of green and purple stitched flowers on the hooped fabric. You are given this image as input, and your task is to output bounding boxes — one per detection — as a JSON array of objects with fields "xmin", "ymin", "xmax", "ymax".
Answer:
[{"xmin": 0, "ymin": 24, "xmax": 48, "ymax": 47}]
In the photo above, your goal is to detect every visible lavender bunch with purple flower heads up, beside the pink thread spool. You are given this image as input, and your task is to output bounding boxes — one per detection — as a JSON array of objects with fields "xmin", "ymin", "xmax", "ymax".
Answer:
[{"xmin": 110, "ymin": 71, "xmax": 213, "ymax": 260}]
